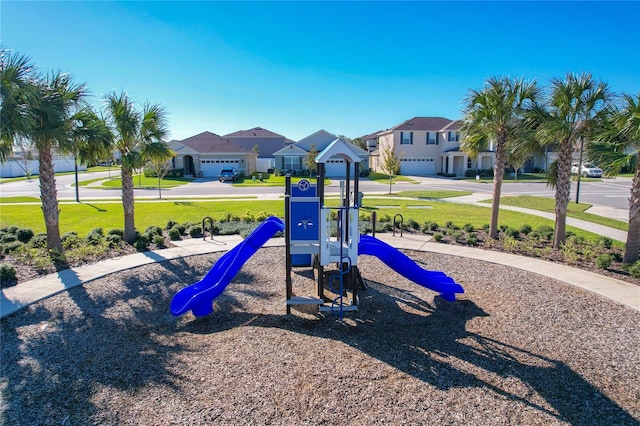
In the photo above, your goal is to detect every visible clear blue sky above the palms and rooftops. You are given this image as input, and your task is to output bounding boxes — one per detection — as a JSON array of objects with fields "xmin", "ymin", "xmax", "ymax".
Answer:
[{"xmin": 0, "ymin": 0, "xmax": 640, "ymax": 140}]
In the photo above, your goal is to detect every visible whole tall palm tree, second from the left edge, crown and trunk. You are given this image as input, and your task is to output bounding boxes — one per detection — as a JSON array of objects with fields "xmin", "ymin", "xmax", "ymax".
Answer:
[{"xmin": 29, "ymin": 72, "xmax": 86, "ymax": 251}]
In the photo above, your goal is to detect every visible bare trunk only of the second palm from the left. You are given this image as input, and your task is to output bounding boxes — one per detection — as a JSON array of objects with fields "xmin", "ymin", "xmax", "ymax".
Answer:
[{"xmin": 38, "ymin": 142, "xmax": 62, "ymax": 253}]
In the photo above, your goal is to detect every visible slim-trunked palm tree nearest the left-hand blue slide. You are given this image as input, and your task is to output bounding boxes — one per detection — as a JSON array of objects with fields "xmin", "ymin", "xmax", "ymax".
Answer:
[{"xmin": 105, "ymin": 92, "xmax": 167, "ymax": 243}]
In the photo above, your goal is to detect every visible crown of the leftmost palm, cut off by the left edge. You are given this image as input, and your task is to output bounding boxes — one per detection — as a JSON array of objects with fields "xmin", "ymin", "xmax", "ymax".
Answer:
[{"xmin": 0, "ymin": 49, "xmax": 39, "ymax": 162}]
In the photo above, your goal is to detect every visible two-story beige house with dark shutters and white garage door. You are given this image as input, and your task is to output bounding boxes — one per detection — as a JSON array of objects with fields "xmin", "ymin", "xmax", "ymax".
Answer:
[{"xmin": 366, "ymin": 117, "xmax": 495, "ymax": 176}]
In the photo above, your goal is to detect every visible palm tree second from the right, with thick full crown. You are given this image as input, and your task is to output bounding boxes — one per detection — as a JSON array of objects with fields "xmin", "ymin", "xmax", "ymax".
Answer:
[{"xmin": 530, "ymin": 73, "xmax": 610, "ymax": 249}]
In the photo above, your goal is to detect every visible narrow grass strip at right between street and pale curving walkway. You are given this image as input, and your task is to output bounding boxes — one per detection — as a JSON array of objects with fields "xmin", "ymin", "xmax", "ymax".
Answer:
[{"xmin": 481, "ymin": 195, "xmax": 629, "ymax": 231}]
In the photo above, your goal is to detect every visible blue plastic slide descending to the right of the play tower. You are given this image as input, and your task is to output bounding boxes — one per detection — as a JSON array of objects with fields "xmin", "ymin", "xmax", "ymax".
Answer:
[{"xmin": 358, "ymin": 235, "xmax": 464, "ymax": 302}]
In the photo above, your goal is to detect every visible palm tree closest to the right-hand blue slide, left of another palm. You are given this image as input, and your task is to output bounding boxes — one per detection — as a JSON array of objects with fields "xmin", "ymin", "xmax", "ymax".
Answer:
[{"xmin": 460, "ymin": 77, "xmax": 539, "ymax": 238}]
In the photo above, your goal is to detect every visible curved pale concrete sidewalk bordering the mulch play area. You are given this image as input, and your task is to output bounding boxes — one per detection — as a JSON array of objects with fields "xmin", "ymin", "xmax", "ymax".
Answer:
[{"xmin": 0, "ymin": 233, "xmax": 640, "ymax": 318}]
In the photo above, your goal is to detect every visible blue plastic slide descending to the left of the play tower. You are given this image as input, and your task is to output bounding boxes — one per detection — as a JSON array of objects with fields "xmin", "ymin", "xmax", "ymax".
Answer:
[{"xmin": 171, "ymin": 216, "xmax": 284, "ymax": 317}]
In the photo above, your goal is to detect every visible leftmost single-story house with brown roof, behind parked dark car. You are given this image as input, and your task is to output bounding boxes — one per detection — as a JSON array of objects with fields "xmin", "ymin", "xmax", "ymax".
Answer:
[{"xmin": 168, "ymin": 132, "xmax": 258, "ymax": 177}]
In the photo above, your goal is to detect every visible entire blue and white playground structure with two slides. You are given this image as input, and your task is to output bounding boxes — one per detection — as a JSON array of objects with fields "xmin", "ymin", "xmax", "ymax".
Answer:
[{"xmin": 171, "ymin": 139, "xmax": 464, "ymax": 319}]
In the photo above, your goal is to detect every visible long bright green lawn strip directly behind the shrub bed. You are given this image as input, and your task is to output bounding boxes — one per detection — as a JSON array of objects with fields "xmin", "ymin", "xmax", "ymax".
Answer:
[{"xmin": 0, "ymin": 197, "xmax": 616, "ymax": 239}]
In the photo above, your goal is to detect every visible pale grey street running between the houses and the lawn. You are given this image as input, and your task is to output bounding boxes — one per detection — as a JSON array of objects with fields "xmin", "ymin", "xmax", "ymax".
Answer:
[{"xmin": 0, "ymin": 170, "xmax": 631, "ymax": 209}]
